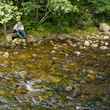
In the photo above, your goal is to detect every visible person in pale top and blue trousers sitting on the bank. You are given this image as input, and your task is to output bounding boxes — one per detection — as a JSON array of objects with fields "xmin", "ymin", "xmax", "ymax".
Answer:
[{"xmin": 13, "ymin": 21, "xmax": 26, "ymax": 39}]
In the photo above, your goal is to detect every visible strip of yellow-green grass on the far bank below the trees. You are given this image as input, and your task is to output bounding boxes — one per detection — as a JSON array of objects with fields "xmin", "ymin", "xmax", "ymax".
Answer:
[{"xmin": 29, "ymin": 24, "xmax": 98, "ymax": 37}]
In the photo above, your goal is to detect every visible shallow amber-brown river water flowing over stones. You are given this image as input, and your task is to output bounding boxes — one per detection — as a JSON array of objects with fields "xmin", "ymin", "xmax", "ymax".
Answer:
[{"xmin": 0, "ymin": 36, "xmax": 110, "ymax": 110}]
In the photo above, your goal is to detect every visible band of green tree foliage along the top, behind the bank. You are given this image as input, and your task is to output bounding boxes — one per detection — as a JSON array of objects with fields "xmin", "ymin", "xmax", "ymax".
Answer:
[{"xmin": 0, "ymin": 0, "xmax": 110, "ymax": 30}]
